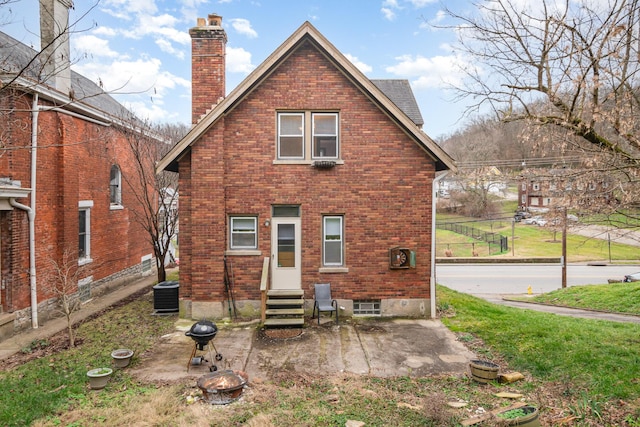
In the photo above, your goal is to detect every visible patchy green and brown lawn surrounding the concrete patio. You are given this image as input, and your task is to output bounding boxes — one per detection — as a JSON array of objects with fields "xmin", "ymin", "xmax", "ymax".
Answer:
[{"xmin": 0, "ymin": 280, "xmax": 640, "ymax": 427}]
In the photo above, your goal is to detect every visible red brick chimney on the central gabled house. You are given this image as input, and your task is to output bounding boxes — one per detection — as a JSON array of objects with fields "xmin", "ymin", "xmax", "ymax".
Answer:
[{"xmin": 189, "ymin": 14, "xmax": 227, "ymax": 124}]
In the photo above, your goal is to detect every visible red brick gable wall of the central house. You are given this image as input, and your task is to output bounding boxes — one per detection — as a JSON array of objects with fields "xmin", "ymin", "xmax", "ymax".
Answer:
[{"xmin": 181, "ymin": 41, "xmax": 435, "ymax": 301}]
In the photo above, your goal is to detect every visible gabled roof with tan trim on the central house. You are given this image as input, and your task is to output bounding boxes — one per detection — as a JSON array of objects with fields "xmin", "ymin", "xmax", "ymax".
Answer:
[{"xmin": 157, "ymin": 22, "xmax": 455, "ymax": 172}]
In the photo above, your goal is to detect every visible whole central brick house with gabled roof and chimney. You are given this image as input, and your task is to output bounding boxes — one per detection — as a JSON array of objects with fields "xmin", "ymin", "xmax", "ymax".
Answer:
[{"xmin": 158, "ymin": 15, "xmax": 454, "ymax": 319}]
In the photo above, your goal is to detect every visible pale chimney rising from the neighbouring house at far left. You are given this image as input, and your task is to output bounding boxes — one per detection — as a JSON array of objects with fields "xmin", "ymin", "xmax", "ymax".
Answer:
[{"xmin": 40, "ymin": 0, "xmax": 73, "ymax": 95}]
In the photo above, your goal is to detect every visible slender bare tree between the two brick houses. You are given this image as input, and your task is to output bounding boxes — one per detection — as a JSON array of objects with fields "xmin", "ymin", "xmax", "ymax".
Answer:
[{"xmin": 122, "ymin": 122, "xmax": 188, "ymax": 282}]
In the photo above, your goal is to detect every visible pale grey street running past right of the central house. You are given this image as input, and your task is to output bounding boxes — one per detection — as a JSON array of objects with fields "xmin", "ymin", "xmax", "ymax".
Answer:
[{"xmin": 436, "ymin": 264, "xmax": 640, "ymax": 295}]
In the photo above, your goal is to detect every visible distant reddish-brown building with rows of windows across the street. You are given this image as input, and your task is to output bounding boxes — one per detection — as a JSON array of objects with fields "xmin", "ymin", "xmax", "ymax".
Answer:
[{"xmin": 518, "ymin": 169, "xmax": 614, "ymax": 210}]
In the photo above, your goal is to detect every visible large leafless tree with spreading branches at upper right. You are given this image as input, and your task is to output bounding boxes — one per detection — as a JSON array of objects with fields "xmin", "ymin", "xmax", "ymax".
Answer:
[{"xmin": 447, "ymin": 0, "xmax": 640, "ymax": 217}]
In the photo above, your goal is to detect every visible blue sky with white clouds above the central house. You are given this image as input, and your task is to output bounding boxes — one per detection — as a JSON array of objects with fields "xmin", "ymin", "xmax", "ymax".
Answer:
[{"xmin": 0, "ymin": 0, "xmax": 480, "ymax": 139}]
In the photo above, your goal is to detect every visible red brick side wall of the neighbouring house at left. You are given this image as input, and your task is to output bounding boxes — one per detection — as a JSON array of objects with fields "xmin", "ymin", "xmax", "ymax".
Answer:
[{"xmin": 0, "ymin": 91, "xmax": 152, "ymax": 311}]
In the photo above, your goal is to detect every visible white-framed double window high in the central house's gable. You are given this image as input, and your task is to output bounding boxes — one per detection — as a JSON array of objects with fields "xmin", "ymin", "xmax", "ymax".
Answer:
[{"xmin": 277, "ymin": 111, "xmax": 340, "ymax": 162}]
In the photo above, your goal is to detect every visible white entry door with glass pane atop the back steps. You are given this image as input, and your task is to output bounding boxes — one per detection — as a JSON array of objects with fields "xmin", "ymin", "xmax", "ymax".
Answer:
[{"xmin": 271, "ymin": 218, "xmax": 302, "ymax": 289}]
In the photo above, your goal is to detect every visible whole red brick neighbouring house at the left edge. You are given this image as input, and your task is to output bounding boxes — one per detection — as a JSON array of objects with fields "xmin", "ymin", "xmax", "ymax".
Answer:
[{"xmin": 0, "ymin": 0, "xmax": 153, "ymax": 338}]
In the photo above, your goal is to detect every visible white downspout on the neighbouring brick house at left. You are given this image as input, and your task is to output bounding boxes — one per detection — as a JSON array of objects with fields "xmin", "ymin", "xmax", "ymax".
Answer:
[{"xmin": 9, "ymin": 93, "xmax": 38, "ymax": 329}]
